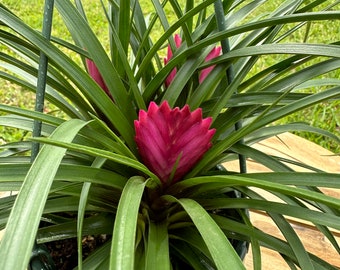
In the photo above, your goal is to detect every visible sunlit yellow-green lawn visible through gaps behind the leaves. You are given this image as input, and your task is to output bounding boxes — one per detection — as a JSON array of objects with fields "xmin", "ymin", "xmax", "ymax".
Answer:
[{"xmin": 0, "ymin": 0, "xmax": 340, "ymax": 153}]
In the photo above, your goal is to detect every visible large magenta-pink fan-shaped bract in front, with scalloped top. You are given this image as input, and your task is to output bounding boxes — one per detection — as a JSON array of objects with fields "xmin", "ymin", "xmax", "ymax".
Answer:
[{"xmin": 134, "ymin": 101, "xmax": 215, "ymax": 184}]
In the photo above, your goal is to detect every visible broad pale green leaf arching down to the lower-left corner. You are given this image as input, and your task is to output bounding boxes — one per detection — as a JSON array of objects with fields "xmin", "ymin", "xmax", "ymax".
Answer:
[{"xmin": 0, "ymin": 119, "xmax": 87, "ymax": 269}]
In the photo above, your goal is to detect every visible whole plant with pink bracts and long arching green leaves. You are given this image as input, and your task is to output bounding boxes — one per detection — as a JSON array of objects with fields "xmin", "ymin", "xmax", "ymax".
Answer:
[{"xmin": 0, "ymin": 0, "xmax": 340, "ymax": 269}]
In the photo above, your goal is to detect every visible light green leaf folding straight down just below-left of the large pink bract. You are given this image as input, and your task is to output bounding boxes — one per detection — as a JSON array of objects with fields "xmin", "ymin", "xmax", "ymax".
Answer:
[{"xmin": 109, "ymin": 176, "xmax": 146, "ymax": 270}]
